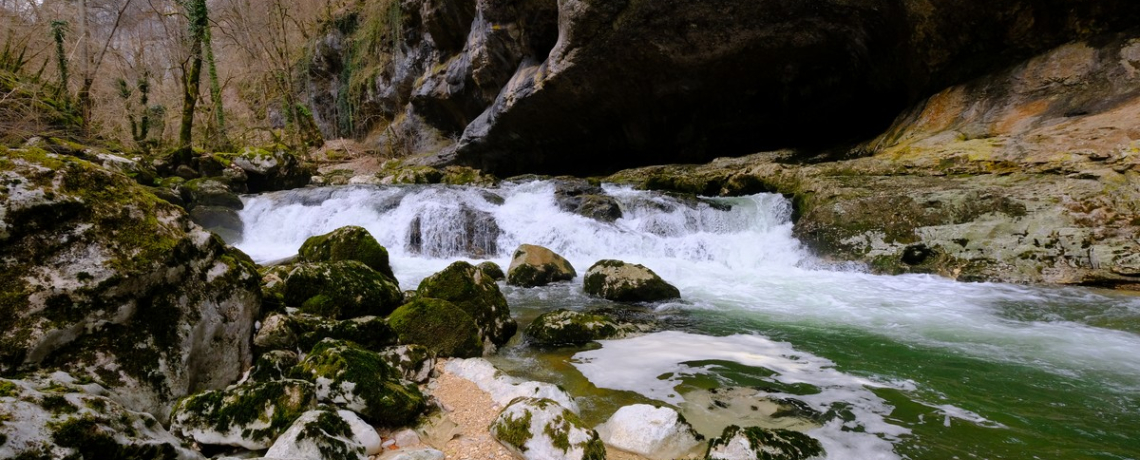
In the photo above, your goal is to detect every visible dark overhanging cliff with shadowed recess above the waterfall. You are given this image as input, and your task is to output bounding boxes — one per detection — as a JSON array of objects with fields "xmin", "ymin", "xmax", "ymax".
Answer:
[{"xmin": 309, "ymin": 0, "xmax": 1140, "ymax": 175}]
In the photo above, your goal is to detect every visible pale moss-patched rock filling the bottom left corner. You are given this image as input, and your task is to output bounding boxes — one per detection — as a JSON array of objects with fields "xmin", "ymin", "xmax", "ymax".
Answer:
[{"xmin": 0, "ymin": 373, "xmax": 203, "ymax": 460}]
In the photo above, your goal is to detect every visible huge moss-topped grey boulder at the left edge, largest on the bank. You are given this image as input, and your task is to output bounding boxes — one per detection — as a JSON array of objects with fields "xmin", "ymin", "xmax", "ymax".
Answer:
[{"xmin": 0, "ymin": 150, "xmax": 260, "ymax": 420}]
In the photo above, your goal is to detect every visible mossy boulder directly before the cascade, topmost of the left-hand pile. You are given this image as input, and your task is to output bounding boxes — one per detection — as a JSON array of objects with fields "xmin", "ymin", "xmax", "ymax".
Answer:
[{"xmin": 300, "ymin": 227, "xmax": 396, "ymax": 280}]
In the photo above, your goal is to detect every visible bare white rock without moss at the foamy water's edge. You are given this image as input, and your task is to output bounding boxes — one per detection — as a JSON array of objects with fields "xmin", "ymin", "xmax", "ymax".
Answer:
[{"xmin": 597, "ymin": 404, "xmax": 702, "ymax": 460}]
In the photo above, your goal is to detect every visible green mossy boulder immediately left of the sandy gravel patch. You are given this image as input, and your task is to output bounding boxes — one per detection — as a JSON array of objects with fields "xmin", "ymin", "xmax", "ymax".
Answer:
[{"xmin": 291, "ymin": 339, "xmax": 424, "ymax": 426}]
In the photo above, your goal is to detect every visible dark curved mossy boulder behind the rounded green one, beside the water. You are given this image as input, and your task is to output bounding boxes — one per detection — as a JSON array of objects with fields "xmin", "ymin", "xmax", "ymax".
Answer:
[{"xmin": 416, "ymin": 261, "xmax": 519, "ymax": 345}]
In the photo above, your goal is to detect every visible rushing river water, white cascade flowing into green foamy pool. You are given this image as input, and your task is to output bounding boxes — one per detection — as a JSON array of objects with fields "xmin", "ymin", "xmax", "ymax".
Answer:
[{"xmin": 237, "ymin": 181, "xmax": 1140, "ymax": 459}]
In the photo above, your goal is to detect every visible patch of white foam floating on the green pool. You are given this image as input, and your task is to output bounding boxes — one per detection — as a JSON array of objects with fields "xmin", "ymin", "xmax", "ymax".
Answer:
[{"xmin": 572, "ymin": 331, "xmax": 913, "ymax": 459}]
